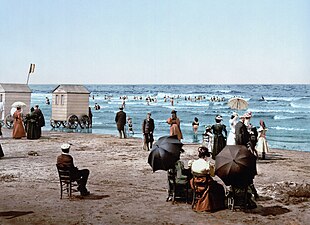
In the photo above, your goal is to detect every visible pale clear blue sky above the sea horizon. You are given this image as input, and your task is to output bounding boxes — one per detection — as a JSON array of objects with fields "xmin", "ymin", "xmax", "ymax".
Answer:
[{"xmin": 0, "ymin": 0, "xmax": 310, "ymax": 84}]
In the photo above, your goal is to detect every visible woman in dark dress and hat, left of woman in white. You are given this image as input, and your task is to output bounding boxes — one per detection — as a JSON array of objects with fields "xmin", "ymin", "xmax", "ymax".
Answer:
[{"xmin": 211, "ymin": 115, "xmax": 227, "ymax": 159}]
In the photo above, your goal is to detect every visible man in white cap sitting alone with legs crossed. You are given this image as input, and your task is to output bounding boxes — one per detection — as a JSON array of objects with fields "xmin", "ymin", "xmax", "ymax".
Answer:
[{"xmin": 57, "ymin": 144, "xmax": 90, "ymax": 196}]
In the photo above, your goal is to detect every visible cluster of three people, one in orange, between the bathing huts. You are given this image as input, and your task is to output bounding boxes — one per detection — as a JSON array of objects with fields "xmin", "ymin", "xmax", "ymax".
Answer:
[{"xmin": 12, "ymin": 105, "xmax": 45, "ymax": 139}]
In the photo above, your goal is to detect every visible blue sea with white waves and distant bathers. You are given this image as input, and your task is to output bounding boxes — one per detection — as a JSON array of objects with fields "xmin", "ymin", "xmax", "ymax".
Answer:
[{"xmin": 30, "ymin": 85, "xmax": 310, "ymax": 151}]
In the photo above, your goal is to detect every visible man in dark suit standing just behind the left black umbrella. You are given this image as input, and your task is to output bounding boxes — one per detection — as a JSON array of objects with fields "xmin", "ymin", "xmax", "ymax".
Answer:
[{"xmin": 142, "ymin": 112, "xmax": 155, "ymax": 151}]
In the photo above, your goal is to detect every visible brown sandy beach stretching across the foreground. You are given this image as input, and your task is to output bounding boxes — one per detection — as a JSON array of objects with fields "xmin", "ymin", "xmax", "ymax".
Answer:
[{"xmin": 0, "ymin": 129, "xmax": 310, "ymax": 225}]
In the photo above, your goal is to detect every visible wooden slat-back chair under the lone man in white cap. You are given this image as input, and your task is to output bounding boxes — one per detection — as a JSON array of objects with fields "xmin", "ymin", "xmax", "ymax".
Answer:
[{"xmin": 56, "ymin": 164, "xmax": 78, "ymax": 199}]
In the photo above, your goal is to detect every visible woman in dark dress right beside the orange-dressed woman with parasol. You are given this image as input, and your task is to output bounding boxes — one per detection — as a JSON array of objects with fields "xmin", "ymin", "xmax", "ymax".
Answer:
[{"xmin": 26, "ymin": 107, "xmax": 41, "ymax": 139}]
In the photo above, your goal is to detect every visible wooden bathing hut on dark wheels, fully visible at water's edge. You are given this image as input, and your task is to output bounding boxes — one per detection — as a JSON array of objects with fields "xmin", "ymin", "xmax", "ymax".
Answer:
[{"xmin": 50, "ymin": 84, "xmax": 90, "ymax": 129}]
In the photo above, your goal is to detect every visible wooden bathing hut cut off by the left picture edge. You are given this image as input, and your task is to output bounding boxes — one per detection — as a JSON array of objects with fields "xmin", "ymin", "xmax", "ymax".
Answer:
[{"xmin": 0, "ymin": 83, "xmax": 31, "ymax": 128}]
